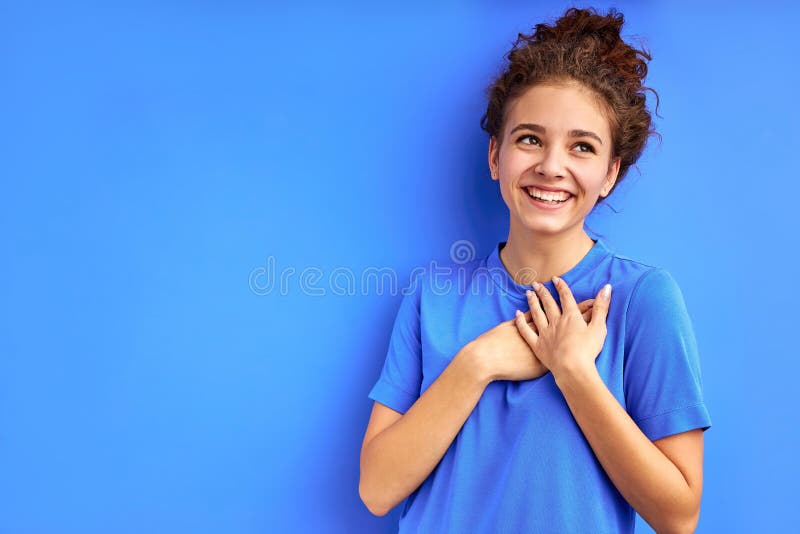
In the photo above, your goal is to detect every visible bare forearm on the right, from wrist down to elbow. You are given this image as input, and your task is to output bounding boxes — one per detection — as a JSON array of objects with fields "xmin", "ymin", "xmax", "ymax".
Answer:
[{"xmin": 555, "ymin": 369, "xmax": 699, "ymax": 534}]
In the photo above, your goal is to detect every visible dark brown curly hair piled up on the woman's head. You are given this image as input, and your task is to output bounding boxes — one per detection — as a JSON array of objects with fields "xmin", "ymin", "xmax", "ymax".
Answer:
[{"xmin": 481, "ymin": 7, "xmax": 661, "ymax": 203}]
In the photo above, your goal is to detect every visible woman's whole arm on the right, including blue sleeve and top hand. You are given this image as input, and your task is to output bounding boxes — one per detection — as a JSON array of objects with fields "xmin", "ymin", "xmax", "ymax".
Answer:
[{"xmin": 518, "ymin": 271, "xmax": 710, "ymax": 533}]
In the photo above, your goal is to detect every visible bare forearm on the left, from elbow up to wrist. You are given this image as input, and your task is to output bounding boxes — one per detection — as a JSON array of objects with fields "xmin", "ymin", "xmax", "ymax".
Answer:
[{"xmin": 359, "ymin": 345, "xmax": 490, "ymax": 515}]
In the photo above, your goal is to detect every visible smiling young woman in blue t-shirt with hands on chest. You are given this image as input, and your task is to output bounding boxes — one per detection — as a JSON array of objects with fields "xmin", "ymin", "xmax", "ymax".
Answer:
[{"xmin": 359, "ymin": 8, "xmax": 711, "ymax": 533}]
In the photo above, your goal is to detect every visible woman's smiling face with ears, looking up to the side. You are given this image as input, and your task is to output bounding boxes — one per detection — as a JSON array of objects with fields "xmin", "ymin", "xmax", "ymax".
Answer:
[{"xmin": 489, "ymin": 84, "xmax": 620, "ymax": 239}]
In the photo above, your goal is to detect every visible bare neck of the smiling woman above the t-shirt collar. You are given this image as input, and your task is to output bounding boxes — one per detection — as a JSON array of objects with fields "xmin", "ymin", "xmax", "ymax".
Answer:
[{"xmin": 500, "ymin": 223, "xmax": 594, "ymax": 285}]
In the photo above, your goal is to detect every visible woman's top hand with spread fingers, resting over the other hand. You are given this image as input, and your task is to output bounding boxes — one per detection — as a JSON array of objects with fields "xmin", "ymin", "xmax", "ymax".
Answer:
[{"xmin": 515, "ymin": 277, "xmax": 611, "ymax": 379}]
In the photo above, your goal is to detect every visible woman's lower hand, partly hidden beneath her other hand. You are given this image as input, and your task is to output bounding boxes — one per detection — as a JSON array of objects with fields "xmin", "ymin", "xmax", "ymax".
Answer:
[{"xmin": 465, "ymin": 299, "xmax": 594, "ymax": 382}]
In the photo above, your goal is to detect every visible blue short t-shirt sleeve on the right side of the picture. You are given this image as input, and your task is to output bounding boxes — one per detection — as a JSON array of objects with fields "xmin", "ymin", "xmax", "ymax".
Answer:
[{"xmin": 623, "ymin": 268, "xmax": 711, "ymax": 441}]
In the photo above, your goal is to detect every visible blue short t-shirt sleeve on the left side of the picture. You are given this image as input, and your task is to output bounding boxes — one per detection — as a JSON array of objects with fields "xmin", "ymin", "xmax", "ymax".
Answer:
[{"xmin": 368, "ymin": 280, "xmax": 422, "ymax": 413}]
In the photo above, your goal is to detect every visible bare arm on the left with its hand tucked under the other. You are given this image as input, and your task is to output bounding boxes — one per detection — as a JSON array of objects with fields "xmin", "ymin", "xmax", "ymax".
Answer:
[{"xmin": 358, "ymin": 299, "xmax": 594, "ymax": 515}]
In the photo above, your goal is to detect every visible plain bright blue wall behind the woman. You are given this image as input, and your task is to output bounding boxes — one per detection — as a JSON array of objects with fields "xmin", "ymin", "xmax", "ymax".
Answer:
[{"xmin": 0, "ymin": 1, "xmax": 800, "ymax": 533}]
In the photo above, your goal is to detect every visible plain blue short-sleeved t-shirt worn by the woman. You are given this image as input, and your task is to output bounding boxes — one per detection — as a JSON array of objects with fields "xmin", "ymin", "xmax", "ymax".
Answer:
[{"xmin": 369, "ymin": 239, "xmax": 711, "ymax": 534}]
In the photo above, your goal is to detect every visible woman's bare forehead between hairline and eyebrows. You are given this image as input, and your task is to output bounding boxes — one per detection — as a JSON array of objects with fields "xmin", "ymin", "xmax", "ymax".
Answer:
[{"xmin": 505, "ymin": 84, "xmax": 610, "ymax": 140}]
